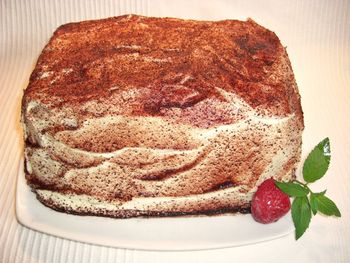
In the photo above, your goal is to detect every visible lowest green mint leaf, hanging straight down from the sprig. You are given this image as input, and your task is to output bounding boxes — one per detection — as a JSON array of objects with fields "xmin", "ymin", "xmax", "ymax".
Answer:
[{"xmin": 292, "ymin": 196, "xmax": 311, "ymax": 240}]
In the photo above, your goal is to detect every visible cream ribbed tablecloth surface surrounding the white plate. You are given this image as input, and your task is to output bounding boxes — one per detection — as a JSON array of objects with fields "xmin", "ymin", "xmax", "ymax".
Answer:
[{"xmin": 0, "ymin": 0, "xmax": 350, "ymax": 262}]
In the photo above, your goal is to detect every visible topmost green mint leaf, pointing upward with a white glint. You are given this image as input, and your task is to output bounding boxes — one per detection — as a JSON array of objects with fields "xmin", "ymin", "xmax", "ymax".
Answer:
[{"xmin": 303, "ymin": 138, "xmax": 331, "ymax": 183}]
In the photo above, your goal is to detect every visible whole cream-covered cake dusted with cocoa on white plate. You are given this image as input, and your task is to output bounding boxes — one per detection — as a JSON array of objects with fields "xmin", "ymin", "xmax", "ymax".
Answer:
[{"xmin": 22, "ymin": 15, "xmax": 304, "ymax": 218}]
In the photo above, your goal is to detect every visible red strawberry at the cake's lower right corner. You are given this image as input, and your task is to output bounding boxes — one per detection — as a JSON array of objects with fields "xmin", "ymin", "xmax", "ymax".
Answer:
[{"xmin": 251, "ymin": 178, "xmax": 290, "ymax": 224}]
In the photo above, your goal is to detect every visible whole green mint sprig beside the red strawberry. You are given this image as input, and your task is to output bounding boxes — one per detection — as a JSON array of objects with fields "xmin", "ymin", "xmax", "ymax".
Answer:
[{"xmin": 275, "ymin": 138, "xmax": 341, "ymax": 240}]
